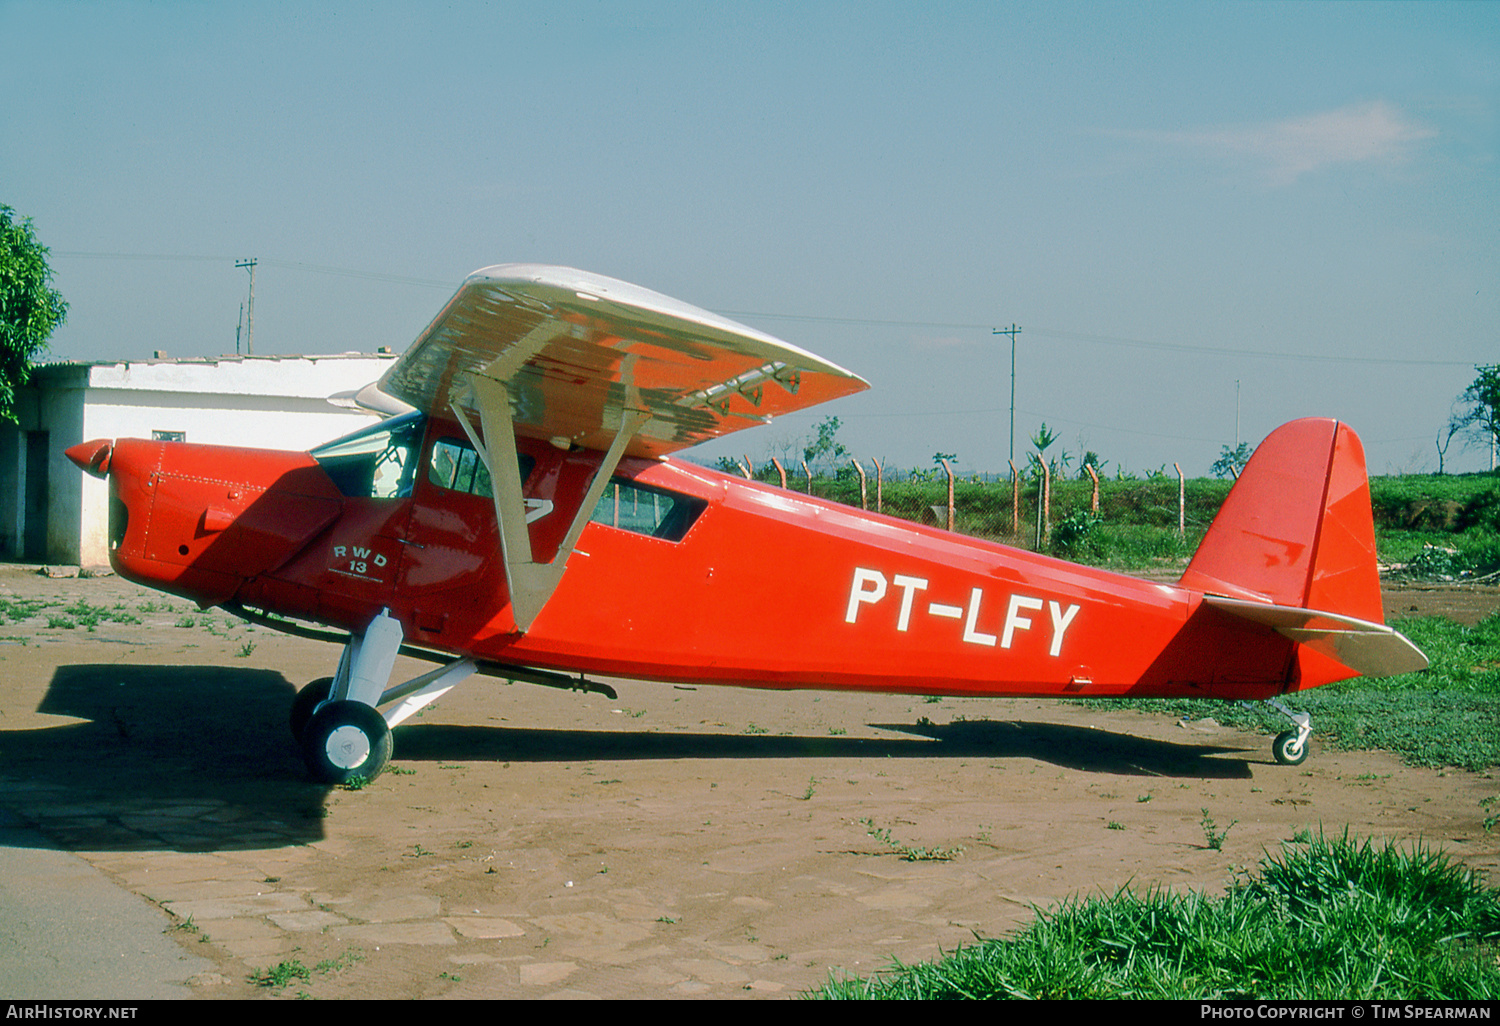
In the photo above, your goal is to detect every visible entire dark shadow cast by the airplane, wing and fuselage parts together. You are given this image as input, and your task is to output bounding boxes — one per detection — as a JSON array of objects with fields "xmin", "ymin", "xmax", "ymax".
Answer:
[{"xmin": 0, "ymin": 665, "xmax": 1250, "ymax": 852}]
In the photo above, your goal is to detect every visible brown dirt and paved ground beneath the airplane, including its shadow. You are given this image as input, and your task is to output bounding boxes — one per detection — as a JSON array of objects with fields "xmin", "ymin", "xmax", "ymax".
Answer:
[{"xmin": 0, "ymin": 567, "xmax": 1500, "ymax": 999}]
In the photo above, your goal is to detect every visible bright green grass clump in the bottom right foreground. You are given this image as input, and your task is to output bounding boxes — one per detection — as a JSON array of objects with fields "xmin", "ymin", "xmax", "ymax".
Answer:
[{"xmin": 810, "ymin": 833, "xmax": 1500, "ymax": 1001}]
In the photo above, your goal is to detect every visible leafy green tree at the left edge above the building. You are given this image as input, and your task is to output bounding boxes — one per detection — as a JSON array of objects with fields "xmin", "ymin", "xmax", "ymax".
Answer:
[{"xmin": 0, "ymin": 204, "xmax": 68, "ymax": 423}]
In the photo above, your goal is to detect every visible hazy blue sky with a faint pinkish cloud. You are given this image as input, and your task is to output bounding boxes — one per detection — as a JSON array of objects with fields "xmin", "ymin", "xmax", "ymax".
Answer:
[{"xmin": 0, "ymin": 0, "xmax": 1500, "ymax": 476}]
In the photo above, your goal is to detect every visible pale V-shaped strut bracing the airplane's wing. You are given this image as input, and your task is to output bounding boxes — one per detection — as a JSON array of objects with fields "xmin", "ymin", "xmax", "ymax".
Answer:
[{"xmin": 453, "ymin": 372, "xmax": 651, "ymax": 635}]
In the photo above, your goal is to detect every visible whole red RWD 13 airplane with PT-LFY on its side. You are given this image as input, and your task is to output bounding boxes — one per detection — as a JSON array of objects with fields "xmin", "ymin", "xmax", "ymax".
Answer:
[{"xmin": 68, "ymin": 264, "xmax": 1427, "ymax": 783}]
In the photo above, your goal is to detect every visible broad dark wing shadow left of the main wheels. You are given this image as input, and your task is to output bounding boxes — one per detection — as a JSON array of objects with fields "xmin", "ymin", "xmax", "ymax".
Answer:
[{"xmin": 0, "ymin": 665, "xmax": 329, "ymax": 851}]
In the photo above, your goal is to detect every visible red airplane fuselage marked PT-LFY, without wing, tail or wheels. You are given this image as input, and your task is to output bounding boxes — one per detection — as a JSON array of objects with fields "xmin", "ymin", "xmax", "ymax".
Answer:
[{"xmin": 90, "ymin": 417, "xmax": 1350, "ymax": 699}]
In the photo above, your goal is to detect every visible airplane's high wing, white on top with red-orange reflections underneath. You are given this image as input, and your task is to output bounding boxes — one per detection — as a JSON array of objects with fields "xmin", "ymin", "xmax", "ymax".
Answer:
[{"xmin": 380, "ymin": 264, "xmax": 870, "ymax": 456}]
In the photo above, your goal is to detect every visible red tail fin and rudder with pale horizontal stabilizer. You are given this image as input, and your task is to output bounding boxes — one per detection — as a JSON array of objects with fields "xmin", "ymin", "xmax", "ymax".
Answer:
[{"xmin": 1181, "ymin": 420, "xmax": 1427, "ymax": 687}]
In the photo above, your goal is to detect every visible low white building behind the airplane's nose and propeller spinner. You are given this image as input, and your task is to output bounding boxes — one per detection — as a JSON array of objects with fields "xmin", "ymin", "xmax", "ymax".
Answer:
[{"xmin": 0, "ymin": 353, "xmax": 396, "ymax": 567}]
